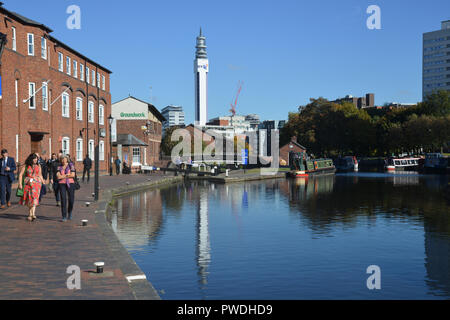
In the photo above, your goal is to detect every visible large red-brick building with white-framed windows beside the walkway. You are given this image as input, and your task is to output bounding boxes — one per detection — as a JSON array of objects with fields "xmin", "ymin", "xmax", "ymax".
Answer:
[{"xmin": 0, "ymin": 3, "xmax": 111, "ymax": 171}]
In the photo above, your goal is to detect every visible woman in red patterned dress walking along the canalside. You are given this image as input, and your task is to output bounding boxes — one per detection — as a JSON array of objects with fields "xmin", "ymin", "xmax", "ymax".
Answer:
[{"xmin": 19, "ymin": 153, "xmax": 44, "ymax": 221}]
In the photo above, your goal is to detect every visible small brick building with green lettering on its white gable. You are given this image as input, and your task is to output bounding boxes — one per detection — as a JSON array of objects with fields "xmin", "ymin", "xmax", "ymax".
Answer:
[{"xmin": 111, "ymin": 96, "xmax": 166, "ymax": 168}]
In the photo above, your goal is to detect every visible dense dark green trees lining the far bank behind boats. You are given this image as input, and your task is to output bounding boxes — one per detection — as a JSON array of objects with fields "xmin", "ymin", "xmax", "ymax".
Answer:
[{"xmin": 280, "ymin": 91, "xmax": 450, "ymax": 156}]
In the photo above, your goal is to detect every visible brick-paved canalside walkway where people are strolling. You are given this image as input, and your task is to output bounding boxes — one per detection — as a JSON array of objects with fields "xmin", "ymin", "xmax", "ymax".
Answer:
[{"xmin": 0, "ymin": 174, "xmax": 178, "ymax": 299}]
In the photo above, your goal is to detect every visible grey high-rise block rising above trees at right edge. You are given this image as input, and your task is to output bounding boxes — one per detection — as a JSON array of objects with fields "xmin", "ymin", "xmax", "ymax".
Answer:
[{"xmin": 422, "ymin": 20, "xmax": 450, "ymax": 98}]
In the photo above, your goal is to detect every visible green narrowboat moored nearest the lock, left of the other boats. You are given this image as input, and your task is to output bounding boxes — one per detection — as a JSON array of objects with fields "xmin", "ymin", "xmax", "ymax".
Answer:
[{"xmin": 288, "ymin": 152, "xmax": 336, "ymax": 177}]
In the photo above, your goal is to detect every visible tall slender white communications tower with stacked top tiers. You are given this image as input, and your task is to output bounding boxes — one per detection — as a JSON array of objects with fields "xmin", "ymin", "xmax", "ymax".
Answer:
[{"xmin": 194, "ymin": 28, "xmax": 209, "ymax": 126}]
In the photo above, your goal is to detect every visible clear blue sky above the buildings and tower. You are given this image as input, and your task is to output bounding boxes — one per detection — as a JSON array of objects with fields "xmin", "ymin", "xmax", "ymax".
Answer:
[{"xmin": 3, "ymin": 0, "xmax": 450, "ymax": 123}]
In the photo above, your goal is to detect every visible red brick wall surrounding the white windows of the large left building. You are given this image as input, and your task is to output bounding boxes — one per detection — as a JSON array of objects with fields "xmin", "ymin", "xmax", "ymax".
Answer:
[{"xmin": 0, "ymin": 13, "xmax": 111, "ymax": 171}]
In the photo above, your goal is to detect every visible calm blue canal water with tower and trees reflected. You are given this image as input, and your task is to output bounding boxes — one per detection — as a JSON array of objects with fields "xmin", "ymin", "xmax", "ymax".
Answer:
[{"xmin": 108, "ymin": 173, "xmax": 450, "ymax": 300}]
